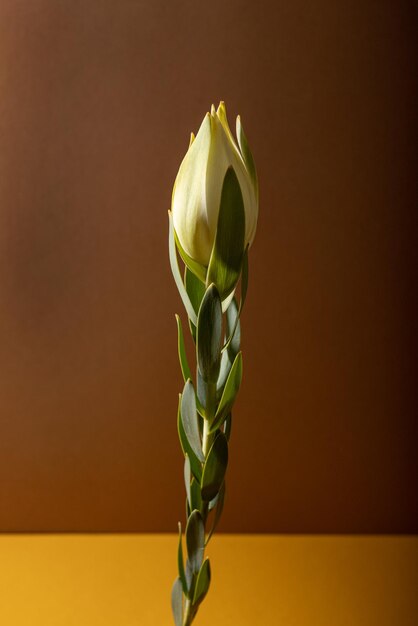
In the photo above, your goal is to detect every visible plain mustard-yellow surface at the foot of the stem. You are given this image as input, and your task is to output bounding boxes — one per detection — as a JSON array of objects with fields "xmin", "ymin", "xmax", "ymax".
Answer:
[{"xmin": 0, "ymin": 535, "xmax": 418, "ymax": 626}]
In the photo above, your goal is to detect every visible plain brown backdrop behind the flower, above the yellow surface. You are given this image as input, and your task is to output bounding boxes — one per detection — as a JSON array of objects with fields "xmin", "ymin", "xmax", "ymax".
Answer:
[{"xmin": 0, "ymin": 0, "xmax": 418, "ymax": 532}]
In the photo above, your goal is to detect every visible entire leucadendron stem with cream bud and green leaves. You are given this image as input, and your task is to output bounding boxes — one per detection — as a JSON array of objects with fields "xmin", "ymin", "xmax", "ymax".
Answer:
[{"xmin": 168, "ymin": 102, "xmax": 258, "ymax": 626}]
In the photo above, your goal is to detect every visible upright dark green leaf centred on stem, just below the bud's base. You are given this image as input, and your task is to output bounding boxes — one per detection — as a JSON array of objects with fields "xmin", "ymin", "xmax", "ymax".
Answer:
[{"xmin": 196, "ymin": 285, "xmax": 222, "ymax": 383}]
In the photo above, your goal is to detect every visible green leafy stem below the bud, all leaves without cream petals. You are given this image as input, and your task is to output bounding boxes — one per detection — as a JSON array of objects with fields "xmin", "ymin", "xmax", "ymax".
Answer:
[{"xmin": 169, "ymin": 167, "xmax": 248, "ymax": 626}]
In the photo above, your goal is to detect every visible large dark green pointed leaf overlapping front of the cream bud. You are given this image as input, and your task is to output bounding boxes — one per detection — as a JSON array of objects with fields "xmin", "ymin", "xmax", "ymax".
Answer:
[{"xmin": 206, "ymin": 166, "xmax": 245, "ymax": 300}]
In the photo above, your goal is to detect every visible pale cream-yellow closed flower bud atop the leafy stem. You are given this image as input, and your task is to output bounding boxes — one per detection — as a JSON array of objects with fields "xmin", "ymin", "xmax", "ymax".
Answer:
[{"xmin": 171, "ymin": 102, "xmax": 258, "ymax": 267}]
